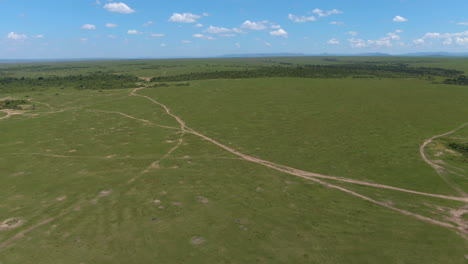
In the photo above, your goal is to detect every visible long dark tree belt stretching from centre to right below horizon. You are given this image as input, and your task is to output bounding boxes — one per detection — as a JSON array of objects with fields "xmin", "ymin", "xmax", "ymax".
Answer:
[{"xmin": 152, "ymin": 64, "xmax": 463, "ymax": 82}]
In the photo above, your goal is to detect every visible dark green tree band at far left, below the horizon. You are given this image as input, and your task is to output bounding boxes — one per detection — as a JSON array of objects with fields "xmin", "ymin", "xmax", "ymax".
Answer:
[{"xmin": 0, "ymin": 72, "xmax": 139, "ymax": 92}]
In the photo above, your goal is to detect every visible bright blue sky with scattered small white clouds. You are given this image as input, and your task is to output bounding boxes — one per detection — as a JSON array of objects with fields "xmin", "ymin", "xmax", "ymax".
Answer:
[{"xmin": 0, "ymin": 0, "xmax": 468, "ymax": 59}]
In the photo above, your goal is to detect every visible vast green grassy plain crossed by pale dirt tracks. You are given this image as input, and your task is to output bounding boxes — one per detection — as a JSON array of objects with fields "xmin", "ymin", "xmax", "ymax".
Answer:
[{"xmin": 0, "ymin": 57, "xmax": 468, "ymax": 264}]
